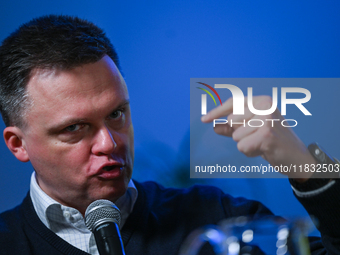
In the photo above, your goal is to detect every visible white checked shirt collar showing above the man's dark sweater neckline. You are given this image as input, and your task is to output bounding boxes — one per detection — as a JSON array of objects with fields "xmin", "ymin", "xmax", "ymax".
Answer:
[{"xmin": 30, "ymin": 172, "xmax": 138, "ymax": 255}]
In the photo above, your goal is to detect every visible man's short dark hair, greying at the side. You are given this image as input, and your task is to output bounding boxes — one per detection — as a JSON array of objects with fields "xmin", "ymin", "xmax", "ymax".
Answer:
[{"xmin": 0, "ymin": 15, "xmax": 121, "ymax": 127}]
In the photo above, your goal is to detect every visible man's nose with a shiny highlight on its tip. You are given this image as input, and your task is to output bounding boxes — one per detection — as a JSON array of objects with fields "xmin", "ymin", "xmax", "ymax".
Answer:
[{"xmin": 92, "ymin": 126, "xmax": 117, "ymax": 155}]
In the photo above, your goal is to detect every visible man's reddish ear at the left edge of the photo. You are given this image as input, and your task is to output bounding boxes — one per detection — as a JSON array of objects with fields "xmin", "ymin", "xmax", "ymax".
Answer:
[{"xmin": 4, "ymin": 127, "xmax": 29, "ymax": 162}]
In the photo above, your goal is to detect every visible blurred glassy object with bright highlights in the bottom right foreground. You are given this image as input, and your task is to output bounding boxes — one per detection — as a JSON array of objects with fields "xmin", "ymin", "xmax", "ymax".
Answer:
[{"xmin": 180, "ymin": 216, "xmax": 313, "ymax": 255}]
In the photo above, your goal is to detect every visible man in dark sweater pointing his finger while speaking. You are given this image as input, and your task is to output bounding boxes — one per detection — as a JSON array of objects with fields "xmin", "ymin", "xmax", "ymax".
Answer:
[{"xmin": 0, "ymin": 16, "xmax": 340, "ymax": 255}]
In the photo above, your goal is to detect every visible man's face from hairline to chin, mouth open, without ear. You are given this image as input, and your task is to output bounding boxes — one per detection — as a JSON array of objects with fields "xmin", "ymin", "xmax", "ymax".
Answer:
[{"xmin": 22, "ymin": 56, "xmax": 134, "ymax": 213}]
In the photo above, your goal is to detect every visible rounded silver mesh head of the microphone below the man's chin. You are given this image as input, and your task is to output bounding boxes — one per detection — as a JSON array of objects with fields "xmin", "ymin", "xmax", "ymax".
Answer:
[{"xmin": 85, "ymin": 199, "xmax": 121, "ymax": 231}]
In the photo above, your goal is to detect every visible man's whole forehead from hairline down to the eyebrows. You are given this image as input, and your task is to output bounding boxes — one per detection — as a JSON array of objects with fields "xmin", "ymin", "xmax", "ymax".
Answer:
[{"xmin": 23, "ymin": 56, "xmax": 128, "ymax": 127}]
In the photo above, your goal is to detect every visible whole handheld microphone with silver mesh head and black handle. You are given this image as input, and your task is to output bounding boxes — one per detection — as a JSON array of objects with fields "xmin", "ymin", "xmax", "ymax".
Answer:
[{"xmin": 85, "ymin": 199, "xmax": 125, "ymax": 255}]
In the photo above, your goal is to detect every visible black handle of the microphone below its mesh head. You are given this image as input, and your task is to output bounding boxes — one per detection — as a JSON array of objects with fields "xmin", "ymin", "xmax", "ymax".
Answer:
[{"xmin": 93, "ymin": 222, "xmax": 125, "ymax": 255}]
